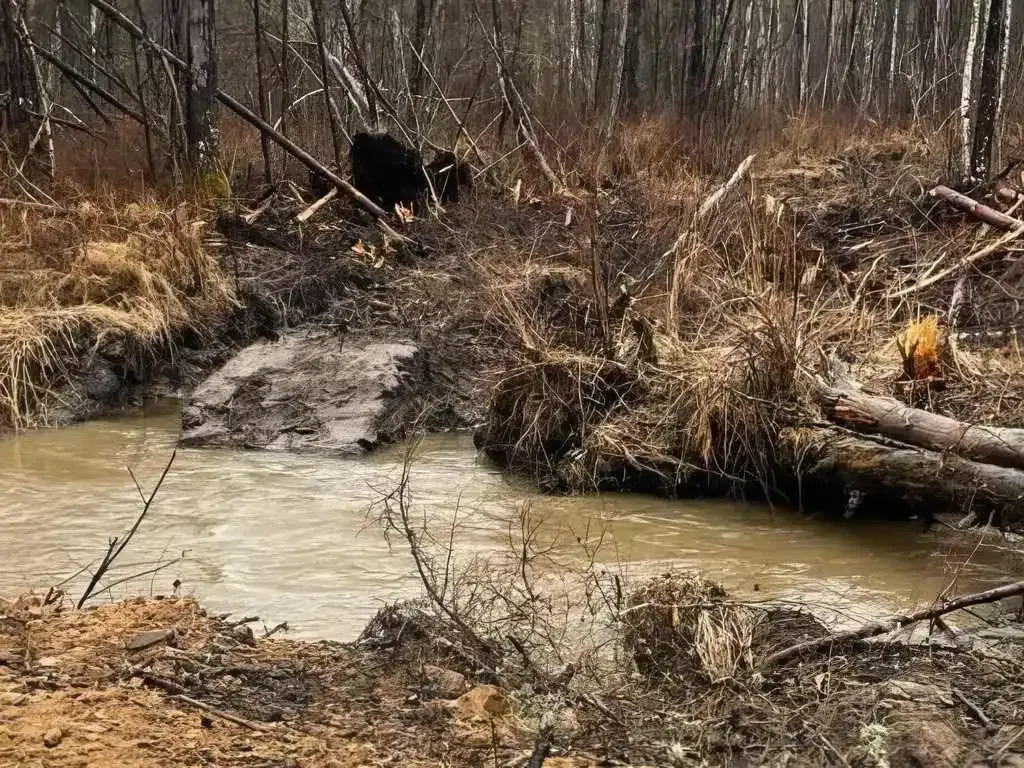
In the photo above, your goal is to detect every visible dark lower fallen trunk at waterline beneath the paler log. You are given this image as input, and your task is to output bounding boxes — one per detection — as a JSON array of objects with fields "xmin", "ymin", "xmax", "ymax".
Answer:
[{"xmin": 782, "ymin": 427, "xmax": 1024, "ymax": 525}]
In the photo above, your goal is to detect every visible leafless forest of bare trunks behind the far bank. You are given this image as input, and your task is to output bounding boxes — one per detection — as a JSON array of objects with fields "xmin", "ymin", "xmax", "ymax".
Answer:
[{"xmin": 0, "ymin": 0, "xmax": 1024, "ymax": 193}]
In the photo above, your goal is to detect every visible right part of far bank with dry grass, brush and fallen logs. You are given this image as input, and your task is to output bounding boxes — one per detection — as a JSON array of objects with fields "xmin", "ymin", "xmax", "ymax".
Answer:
[{"xmin": 477, "ymin": 134, "xmax": 1024, "ymax": 524}]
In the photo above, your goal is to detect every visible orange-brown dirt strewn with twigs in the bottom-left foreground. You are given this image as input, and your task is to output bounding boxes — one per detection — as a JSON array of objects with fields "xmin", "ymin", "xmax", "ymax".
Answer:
[{"xmin": 0, "ymin": 598, "xmax": 593, "ymax": 768}]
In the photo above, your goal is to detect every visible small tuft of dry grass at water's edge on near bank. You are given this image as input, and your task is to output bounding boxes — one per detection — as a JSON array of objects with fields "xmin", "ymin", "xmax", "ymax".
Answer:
[{"xmin": 623, "ymin": 572, "xmax": 761, "ymax": 683}]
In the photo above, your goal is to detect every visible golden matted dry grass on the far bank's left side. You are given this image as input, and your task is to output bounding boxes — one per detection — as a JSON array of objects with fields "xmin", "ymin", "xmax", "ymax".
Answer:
[{"xmin": 0, "ymin": 195, "xmax": 234, "ymax": 429}]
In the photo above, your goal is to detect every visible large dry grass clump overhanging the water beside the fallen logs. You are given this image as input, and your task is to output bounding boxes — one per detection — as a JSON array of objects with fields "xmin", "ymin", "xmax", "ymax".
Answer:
[{"xmin": 475, "ymin": 177, "xmax": 862, "ymax": 493}]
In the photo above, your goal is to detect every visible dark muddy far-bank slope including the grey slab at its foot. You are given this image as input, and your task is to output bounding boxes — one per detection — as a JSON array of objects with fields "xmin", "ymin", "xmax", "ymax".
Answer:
[{"xmin": 3, "ymin": 199, "xmax": 494, "ymax": 453}]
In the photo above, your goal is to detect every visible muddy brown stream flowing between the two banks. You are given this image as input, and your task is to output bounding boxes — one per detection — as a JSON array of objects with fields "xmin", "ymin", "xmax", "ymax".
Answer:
[{"xmin": 0, "ymin": 401, "xmax": 1008, "ymax": 640}]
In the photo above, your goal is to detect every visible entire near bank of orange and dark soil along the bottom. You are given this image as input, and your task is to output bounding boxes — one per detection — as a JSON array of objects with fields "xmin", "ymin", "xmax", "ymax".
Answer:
[{"xmin": 6, "ymin": 585, "xmax": 1024, "ymax": 768}]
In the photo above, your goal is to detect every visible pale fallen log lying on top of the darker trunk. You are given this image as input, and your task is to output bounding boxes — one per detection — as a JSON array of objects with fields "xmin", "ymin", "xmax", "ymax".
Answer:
[{"xmin": 818, "ymin": 380, "xmax": 1024, "ymax": 469}]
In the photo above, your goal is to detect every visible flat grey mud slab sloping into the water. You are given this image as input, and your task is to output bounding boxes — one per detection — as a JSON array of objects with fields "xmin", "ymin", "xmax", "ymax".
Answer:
[{"xmin": 181, "ymin": 331, "xmax": 417, "ymax": 455}]
